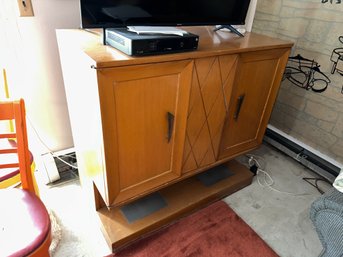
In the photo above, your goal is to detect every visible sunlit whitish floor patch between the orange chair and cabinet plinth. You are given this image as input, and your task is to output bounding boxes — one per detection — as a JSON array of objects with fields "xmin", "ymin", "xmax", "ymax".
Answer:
[{"xmin": 37, "ymin": 176, "xmax": 111, "ymax": 257}]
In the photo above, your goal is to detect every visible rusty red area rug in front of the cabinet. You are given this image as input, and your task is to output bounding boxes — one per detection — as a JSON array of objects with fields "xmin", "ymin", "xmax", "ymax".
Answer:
[{"xmin": 111, "ymin": 201, "xmax": 278, "ymax": 257}]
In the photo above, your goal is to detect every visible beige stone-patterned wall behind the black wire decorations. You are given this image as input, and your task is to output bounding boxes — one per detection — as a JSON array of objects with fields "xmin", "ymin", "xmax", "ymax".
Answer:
[{"xmin": 252, "ymin": 0, "xmax": 343, "ymax": 163}]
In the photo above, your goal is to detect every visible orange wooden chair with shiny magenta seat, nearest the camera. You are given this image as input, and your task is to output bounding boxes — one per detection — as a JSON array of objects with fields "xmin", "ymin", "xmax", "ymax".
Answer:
[{"xmin": 0, "ymin": 99, "xmax": 51, "ymax": 257}]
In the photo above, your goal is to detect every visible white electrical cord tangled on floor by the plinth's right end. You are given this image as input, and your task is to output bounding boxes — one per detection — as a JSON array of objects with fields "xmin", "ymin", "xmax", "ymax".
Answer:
[{"xmin": 245, "ymin": 154, "xmax": 311, "ymax": 196}]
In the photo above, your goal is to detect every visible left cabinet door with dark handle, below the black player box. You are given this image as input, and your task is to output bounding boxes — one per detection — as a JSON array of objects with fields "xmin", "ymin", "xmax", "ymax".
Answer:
[{"xmin": 98, "ymin": 61, "xmax": 193, "ymax": 205}]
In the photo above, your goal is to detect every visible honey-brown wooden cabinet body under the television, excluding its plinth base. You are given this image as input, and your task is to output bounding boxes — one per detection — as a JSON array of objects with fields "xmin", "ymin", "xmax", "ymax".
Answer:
[{"xmin": 57, "ymin": 27, "xmax": 292, "ymax": 208}]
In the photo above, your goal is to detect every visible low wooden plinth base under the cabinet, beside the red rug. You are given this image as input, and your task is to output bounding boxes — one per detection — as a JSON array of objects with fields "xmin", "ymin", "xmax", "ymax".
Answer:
[{"xmin": 97, "ymin": 161, "xmax": 253, "ymax": 251}]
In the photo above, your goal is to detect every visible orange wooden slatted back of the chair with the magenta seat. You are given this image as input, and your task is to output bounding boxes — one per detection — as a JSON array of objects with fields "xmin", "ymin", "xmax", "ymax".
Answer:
[{"xmin": 0, "ymin": 99, "xmax": 38, "ymax": 194}]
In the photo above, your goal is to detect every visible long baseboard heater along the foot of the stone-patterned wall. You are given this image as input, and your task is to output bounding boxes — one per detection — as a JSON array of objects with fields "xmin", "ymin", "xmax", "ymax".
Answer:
[{"xmin": 263, "ymin": 125, "xmax": 342, "ymax": 182}]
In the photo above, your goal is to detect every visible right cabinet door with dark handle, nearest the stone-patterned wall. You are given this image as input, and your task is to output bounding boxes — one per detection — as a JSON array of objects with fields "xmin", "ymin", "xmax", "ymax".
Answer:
[{"xmin": 221, "ymin": 49, "xmax": 289, "ymax": 157}]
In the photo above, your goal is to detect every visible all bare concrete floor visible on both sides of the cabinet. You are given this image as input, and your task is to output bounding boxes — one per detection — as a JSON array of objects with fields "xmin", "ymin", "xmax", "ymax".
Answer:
[{"xmin": 41, "ymin": 145, "xmax": 327, "ymax": 257}]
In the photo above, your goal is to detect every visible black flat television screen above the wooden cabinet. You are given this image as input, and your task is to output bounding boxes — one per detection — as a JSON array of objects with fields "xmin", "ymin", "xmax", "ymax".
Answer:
[{"xmin": 80, "ymin": 0, "xmax": 250, "ymax": 28}]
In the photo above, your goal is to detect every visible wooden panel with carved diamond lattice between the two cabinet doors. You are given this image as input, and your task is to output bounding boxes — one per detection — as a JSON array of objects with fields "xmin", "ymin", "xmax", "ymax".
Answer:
[{"xmin": 182, "ymin": 55, "xmax": 237, "ymax": 173}]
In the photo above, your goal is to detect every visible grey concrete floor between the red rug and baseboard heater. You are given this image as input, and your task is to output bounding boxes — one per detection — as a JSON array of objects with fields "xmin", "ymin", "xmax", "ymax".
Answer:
[{"xmin": 224, "ymin": 145, "xmax": 329, "ymax": 257}]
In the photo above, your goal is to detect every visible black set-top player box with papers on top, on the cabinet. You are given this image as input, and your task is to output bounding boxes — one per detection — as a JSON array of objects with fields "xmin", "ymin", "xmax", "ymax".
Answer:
[{"xmin": 105, "ymin": 28, "xmax": 199, "ymax": 56}]
